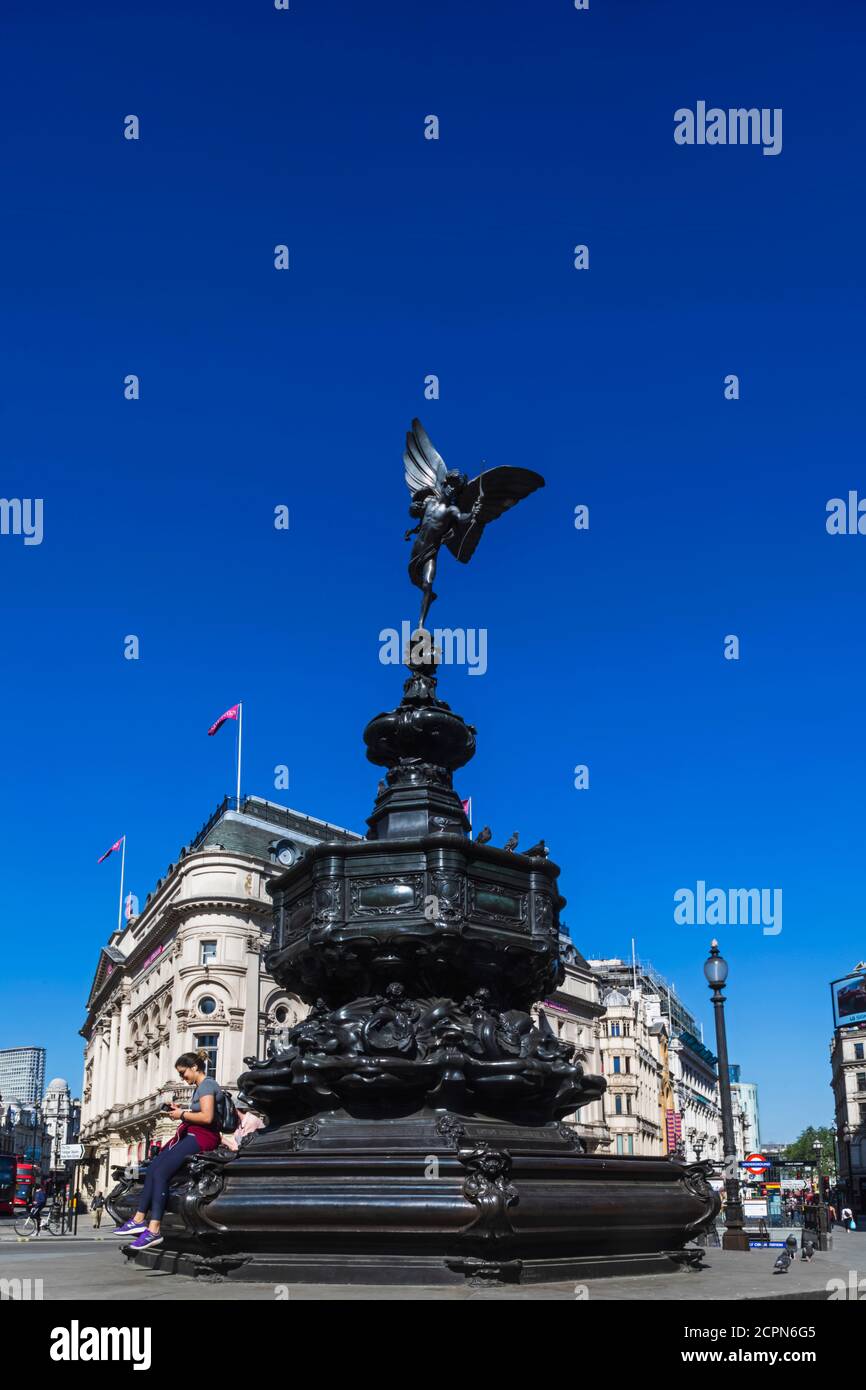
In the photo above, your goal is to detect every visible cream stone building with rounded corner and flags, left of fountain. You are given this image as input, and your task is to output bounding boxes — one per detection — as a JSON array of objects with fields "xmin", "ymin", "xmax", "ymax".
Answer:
[{"xmin": 81, "ymin": 796, "xmax": 361, "ymax": 1191}]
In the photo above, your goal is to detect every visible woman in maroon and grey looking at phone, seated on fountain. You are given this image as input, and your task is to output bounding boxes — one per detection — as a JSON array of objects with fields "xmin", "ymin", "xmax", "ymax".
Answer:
[{"xmin": 111, "ymin": 1049, "xmax": 222, "ymax": 1250}]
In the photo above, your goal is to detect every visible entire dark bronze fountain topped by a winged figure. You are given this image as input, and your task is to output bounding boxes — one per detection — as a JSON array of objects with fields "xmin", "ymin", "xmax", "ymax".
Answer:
[{"xmin": 115, "ymin": 421, "xmax": 719, "ymax": 1284}]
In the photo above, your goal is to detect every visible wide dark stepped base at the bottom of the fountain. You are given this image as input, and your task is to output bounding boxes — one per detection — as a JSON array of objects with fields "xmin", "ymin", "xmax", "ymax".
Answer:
[{"xmin": 110, "ymin": 1112, "xmax": 719, "ymax": 1286}]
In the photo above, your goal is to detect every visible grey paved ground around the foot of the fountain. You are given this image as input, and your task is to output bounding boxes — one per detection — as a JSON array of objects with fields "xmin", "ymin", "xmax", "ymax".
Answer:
[{"xmin": 0, "ymin": 1223, "xmax": 866, "ymax": 1302}]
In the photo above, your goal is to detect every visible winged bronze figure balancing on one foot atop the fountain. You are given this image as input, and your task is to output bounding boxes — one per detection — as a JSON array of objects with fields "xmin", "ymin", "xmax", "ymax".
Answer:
[{"xmin": 403, "ymin": 420, "xmax": 545, "ymax": 628}]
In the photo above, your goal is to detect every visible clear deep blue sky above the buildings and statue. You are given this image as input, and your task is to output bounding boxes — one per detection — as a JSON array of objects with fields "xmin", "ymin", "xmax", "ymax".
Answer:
[{"xmin": 0, "ymin": 0, "xmax": 866, "ymax": 1140}]
